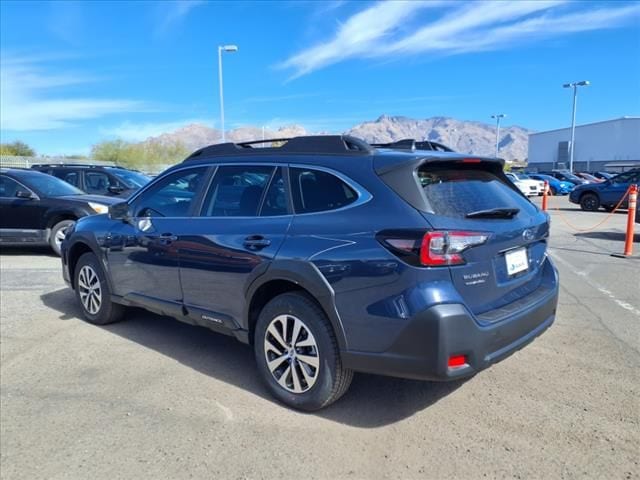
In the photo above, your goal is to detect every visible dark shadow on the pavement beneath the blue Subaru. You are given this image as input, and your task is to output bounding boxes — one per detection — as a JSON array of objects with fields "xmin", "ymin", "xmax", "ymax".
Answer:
[{"xmin": 40, "ymin": 289, "xmax": 464, "ymax": 428}]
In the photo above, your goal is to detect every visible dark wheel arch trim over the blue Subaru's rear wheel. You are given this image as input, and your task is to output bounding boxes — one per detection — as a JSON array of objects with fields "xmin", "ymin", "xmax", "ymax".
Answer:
[{"xmin": 242, "ymin": 260, "xmax": 348, "ymax": 351}]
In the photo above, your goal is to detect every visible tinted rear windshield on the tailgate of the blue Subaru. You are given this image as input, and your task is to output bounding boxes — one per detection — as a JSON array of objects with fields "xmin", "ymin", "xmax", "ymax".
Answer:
[{"xmin": 418, "ymin": 167, "xmax": 536, "ymax": 218}]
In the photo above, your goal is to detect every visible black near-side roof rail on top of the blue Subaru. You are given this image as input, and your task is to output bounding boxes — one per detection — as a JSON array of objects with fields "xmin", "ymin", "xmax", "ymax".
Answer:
[{"xmin": 184, "ymin": 135, "xmax": 373, "ymax": 162}]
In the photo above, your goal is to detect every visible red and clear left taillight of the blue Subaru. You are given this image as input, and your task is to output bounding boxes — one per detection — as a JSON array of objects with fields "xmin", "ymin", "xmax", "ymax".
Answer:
[{"xmin": 379, "ymin": 230, "xmax": 489, "ymax": 267}]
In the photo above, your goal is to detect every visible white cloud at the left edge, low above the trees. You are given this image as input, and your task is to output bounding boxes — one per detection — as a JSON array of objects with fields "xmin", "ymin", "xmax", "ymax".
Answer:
[{"xmin": 0, "ymin": 54, "xmax": 150, "ymax": 131}]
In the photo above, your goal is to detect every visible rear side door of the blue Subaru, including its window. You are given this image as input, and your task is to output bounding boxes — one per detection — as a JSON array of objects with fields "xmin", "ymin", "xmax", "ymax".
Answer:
[{"xmin": 179, "ymin": 165, "xmax": 292, "ymax": 328}]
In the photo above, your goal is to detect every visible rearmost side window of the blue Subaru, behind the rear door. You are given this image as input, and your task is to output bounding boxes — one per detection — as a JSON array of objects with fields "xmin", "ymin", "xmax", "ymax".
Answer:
[{"xmin": 289, "ymin": 168, "xmax": 358, "ymax": 213}]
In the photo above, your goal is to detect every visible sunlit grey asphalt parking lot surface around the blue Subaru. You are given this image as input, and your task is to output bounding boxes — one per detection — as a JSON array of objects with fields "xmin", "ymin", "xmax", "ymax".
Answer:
[{"xmin": 0, "ymin": 197, "xmax": 640, "ymax": 479}]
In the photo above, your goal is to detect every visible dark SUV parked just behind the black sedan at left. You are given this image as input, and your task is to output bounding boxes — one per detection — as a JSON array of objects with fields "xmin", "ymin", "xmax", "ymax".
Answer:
[{"xmin": 31, "ymin": 163, "xmax": 151, "ymax": 198}]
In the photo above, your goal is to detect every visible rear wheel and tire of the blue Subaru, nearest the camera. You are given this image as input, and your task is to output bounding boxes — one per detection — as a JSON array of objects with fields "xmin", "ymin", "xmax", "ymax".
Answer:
[{"xmin": 254, "ymin": 292, "xmax": 353, "ymax": 412}]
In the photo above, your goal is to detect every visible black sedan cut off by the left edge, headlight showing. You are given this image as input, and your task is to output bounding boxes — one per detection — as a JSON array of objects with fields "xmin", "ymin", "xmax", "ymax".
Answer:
[{"xmin": 0, "ymin": 168, "xmax": 117, "ymax": 254}]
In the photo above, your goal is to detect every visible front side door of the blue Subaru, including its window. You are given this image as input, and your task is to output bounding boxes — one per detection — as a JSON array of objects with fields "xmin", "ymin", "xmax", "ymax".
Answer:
[{"xmin": 105, "ymin": 167, "xmax": 210, "ymax": 315}]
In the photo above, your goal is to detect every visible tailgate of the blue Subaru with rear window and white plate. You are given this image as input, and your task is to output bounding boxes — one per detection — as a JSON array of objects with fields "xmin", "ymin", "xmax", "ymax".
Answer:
[{"xmin": 418, "ymin": 163, "xmax": 549, "ymax": 314}]
